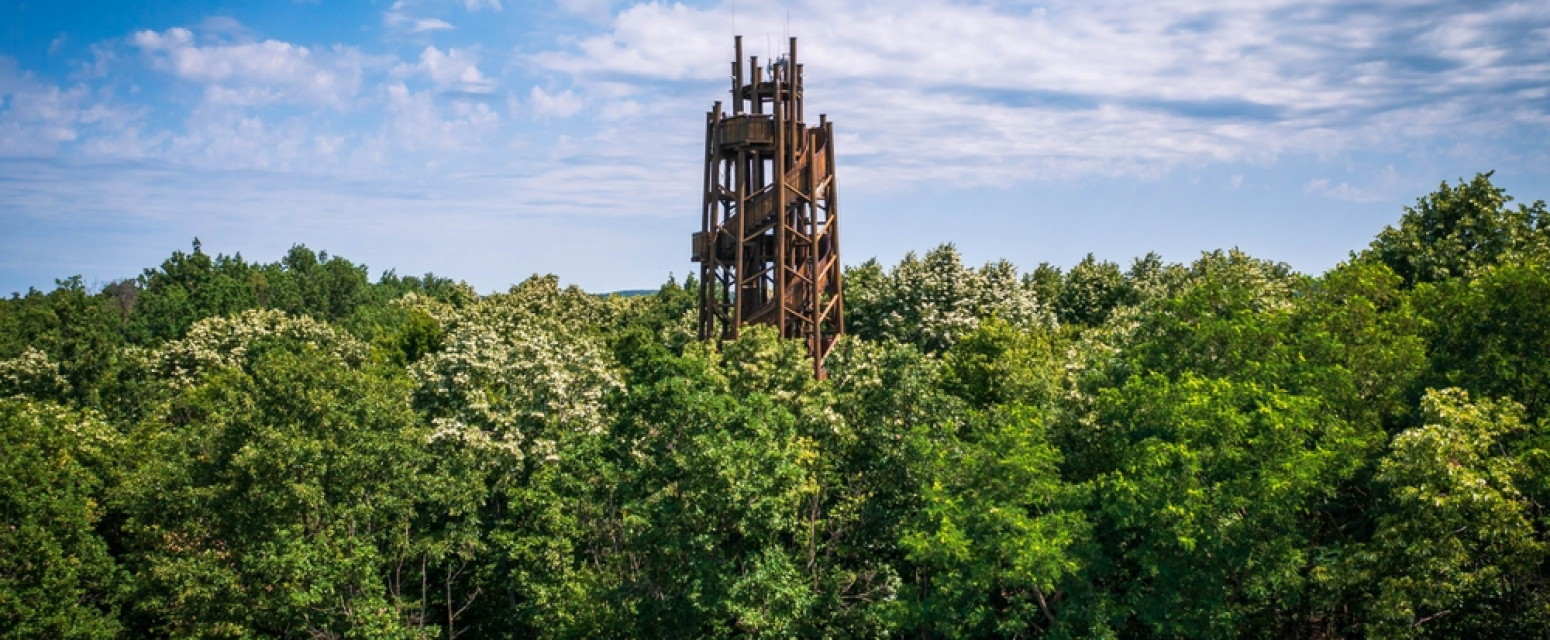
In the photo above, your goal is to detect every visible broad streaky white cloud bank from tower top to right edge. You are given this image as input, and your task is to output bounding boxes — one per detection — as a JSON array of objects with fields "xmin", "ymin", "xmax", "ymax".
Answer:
[{"xmin": 525, "ymin": 0, "xmax": 1550, "ymax": 189}]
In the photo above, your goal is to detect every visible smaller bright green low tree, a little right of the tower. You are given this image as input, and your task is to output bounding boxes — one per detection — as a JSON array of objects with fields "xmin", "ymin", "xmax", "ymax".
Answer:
[{"xmin": 901, "ymin": 404, "xmax": 1091, "ymax": 637}]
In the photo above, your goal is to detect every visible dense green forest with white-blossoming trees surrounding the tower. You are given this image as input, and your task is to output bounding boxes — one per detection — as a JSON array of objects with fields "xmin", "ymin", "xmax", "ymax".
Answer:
[{"xmin": 0, "ymin": 174, "xmax": 1550, "ymax": 638}]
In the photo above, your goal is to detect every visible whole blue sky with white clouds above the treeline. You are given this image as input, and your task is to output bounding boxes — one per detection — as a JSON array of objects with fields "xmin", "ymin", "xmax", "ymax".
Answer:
[{"xmin": 0, "ymin": 0, "xmax": 1550, "ymax": 291}]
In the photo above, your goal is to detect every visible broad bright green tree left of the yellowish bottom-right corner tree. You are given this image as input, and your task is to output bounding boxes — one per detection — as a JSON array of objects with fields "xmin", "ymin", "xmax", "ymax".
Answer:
[{"xmin": 1088, "ymin": 373, "xmax": 1367, "ymax": 637}]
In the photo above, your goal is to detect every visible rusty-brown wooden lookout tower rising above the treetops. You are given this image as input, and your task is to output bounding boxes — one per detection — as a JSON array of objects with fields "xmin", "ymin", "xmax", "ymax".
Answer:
[{"xmin": 693, "ymin": 36, "xmax": 845, "ymax": 378}]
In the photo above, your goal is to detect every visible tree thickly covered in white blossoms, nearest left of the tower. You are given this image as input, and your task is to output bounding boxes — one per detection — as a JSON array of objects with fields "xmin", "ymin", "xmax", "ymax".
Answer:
[{"xmin": 398, "ymin": 271, "xmax": 623, "ymax": 637}]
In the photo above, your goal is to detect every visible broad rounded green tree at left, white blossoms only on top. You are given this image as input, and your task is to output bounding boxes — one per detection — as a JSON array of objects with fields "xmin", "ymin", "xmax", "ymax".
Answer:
[{"xmin": 110, "ymin": 311, "xmax": 436, "ymax": 637}]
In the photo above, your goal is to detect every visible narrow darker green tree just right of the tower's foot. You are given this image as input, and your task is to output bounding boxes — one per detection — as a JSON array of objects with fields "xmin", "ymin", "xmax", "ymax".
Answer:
[{"xmin": 809, "ymin": 338, "xmax": 964, "ymax": 637}]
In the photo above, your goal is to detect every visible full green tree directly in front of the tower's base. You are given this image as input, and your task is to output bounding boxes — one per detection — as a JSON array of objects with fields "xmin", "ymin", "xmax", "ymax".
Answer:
[{"xmin": 594, "ymin": 327, "xmax": 818, "ymax": 637}]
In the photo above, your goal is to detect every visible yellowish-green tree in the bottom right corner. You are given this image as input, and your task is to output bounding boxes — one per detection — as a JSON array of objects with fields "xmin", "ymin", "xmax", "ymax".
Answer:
[{"xmin": 1338, "ymin": 389, "xmax": 1550, "ymax": 638}]
